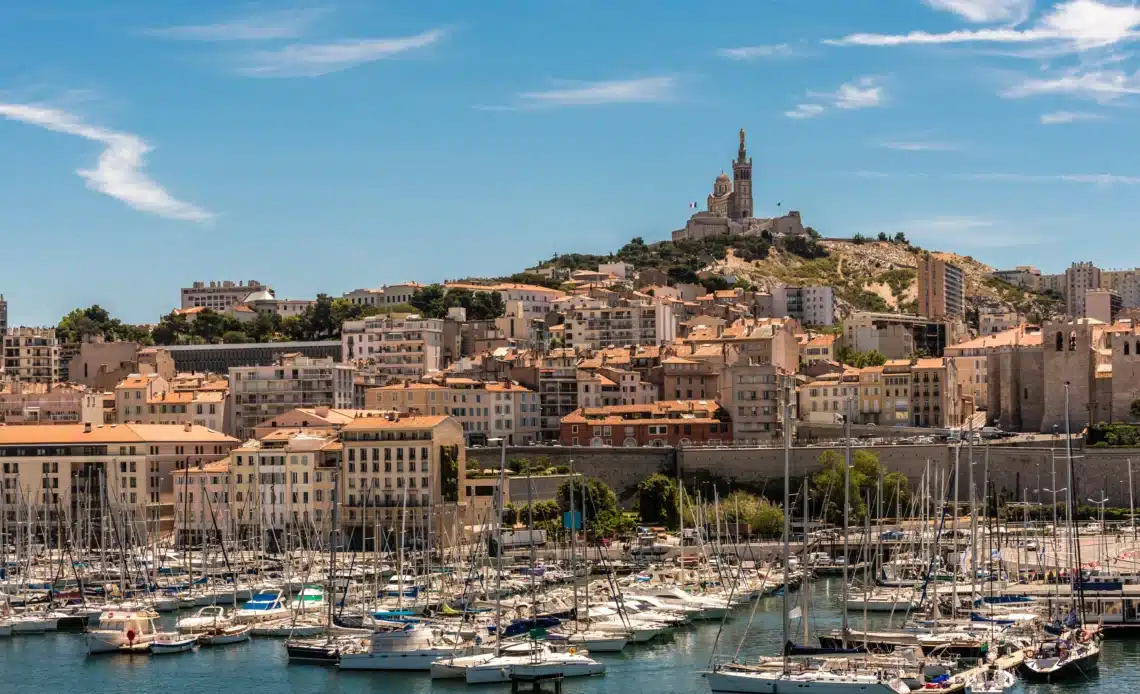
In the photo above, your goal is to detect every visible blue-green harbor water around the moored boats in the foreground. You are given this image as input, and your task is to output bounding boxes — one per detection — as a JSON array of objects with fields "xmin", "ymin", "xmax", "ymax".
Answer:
[{"xmin": 0, "ymin": 580, "xmax": 1140, "ymax": 694}]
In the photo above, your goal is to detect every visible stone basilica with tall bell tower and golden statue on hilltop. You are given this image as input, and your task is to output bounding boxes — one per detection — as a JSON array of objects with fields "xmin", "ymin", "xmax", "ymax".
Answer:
[{"xmin": 673, "ymin": 129, "xmax": 805, "ymax": 240}]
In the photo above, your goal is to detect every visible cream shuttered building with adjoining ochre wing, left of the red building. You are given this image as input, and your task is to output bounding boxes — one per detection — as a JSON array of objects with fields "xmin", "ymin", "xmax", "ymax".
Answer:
[{"xmin": 365, "ymin": 378, "xmax": 542, "ymax": 446}]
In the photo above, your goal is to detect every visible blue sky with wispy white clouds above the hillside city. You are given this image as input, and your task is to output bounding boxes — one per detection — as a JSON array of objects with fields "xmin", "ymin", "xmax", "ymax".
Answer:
[{"xmin": 0, "ymin": 0, "xmax": 1140, "ymax": 325}]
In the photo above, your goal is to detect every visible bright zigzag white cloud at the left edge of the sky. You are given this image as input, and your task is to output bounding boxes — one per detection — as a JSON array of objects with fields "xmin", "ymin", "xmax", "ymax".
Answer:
[{"xmin": 0, "ymin": 104, "xmax": 213, "ymax": 221}]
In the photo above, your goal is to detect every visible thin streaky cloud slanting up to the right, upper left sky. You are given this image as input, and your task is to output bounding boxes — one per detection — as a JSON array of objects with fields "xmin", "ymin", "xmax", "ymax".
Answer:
[{"xmin": 238, "ymin": 28, "xmax": 446, "ymax": 77}]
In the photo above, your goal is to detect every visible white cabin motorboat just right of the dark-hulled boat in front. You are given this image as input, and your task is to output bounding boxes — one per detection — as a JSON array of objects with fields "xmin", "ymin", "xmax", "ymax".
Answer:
[{"xmin": 340, "ymin": 624, "xmax": 480, "ymax": 671}]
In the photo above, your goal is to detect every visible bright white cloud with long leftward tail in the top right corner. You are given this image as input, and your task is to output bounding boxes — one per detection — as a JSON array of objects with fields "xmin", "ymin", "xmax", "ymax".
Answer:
[{"xmin": 825, "ymin": 0, "xmax": 1140, "ymax": 52}]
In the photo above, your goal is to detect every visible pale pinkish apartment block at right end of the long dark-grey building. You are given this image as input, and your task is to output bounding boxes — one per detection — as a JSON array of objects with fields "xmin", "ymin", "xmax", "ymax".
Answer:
[{"xmin": 341, "ymin": 316, "xmax": 445, "ymax": 378}]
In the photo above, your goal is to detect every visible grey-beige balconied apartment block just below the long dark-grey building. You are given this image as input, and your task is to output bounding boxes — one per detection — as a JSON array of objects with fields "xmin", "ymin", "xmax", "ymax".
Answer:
[{"xmin": 229, "ymin": 354, "xmax": 344, "ymax": 441}]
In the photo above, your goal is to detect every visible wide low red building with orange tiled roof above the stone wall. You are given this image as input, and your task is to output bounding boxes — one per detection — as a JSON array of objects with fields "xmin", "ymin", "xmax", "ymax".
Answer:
[{"xmin": 560, "ymin": 400, "xmax": 732, "ymax": 448}]
